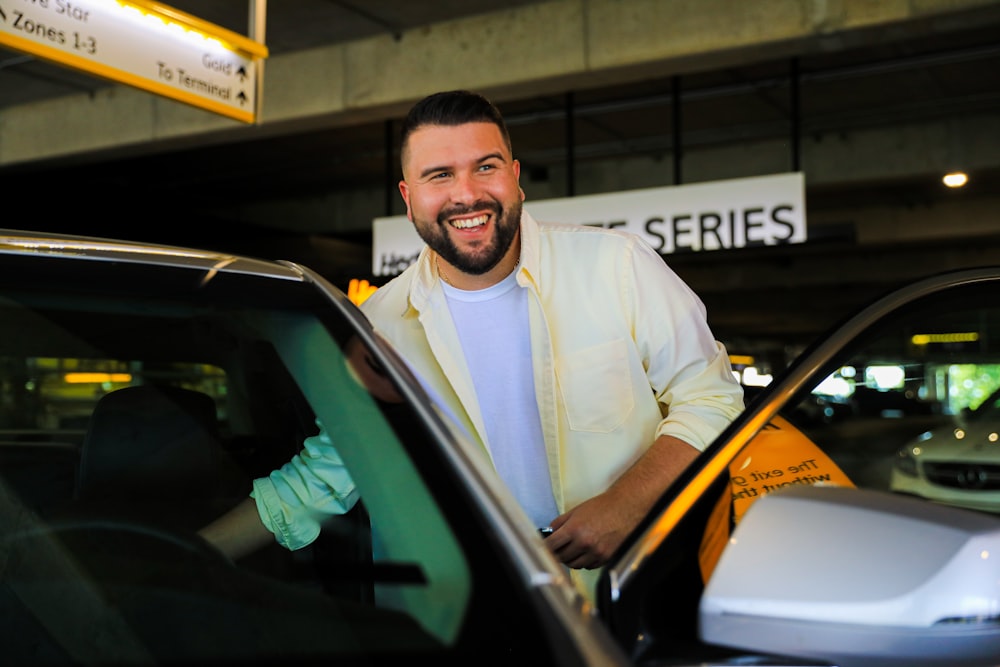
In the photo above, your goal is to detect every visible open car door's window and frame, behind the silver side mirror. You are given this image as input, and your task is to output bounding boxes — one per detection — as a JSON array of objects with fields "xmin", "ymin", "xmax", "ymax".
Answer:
[{"xmin": 600, "ymin": 272, "xmax": 1000, "ymax": 664}]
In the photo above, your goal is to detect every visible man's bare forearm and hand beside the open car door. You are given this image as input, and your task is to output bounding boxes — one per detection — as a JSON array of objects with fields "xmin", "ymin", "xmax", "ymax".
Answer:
[{"xmin": 545, "ymin": 436, "xmax": 699, "ymax": 569}]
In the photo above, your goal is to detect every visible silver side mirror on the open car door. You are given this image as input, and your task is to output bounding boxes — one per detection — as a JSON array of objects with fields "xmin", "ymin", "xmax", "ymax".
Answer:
[{"xmin": 699, "ymin": 487, "xmax": 1000, "ymax": 667}]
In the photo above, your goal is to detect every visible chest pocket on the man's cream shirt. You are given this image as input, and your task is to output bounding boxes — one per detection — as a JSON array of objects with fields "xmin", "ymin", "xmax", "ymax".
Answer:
[{"xmin": 556, "ymin": 339, "xmax": 635, "ymax": 433}]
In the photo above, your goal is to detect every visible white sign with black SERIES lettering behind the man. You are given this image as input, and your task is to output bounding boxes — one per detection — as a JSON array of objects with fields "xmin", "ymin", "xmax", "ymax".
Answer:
[{"xmin": 372, "ymin": 172, "xmax": 806, "ymax": 276}]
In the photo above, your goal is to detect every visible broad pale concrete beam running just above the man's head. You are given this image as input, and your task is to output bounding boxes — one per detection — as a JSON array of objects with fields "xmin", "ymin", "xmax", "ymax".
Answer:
[{"xmin": 0, "ymin": 0, "xmax": 1000, "ymax": 166}]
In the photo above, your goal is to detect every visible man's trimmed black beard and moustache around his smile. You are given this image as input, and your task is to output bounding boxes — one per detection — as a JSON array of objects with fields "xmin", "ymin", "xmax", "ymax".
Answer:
[{"xmin": 416, "ymin": 201, "xmax": 522, "ymax": 276}]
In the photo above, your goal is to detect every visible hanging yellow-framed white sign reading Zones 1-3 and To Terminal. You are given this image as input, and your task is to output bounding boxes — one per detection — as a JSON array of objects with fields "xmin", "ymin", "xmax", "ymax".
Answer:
[{"xmin": 0, "ymin": 0, "xmax": 267, "ymax": 123}]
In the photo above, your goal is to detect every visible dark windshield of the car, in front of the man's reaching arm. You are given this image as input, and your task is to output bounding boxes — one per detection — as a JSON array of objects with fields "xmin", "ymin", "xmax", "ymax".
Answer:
[{"xmin": 0, "ymin": 256, "xmax": 559, "ymax": 665}]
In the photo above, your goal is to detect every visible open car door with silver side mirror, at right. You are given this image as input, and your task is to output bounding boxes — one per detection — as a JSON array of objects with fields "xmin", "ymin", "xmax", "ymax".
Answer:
[{"xmin": 598, "ymin": 268, "xmax": 1000, "ymax": 665}]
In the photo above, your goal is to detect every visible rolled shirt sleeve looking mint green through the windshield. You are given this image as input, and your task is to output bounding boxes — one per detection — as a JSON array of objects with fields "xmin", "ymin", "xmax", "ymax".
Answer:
[{"xmin": 250, "ymin": 420, "xmax": 359, "ymax": 550}]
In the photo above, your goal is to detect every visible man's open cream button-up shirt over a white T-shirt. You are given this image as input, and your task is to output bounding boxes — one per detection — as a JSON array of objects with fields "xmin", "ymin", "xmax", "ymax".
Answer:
[{"xmin": 362, "ymin": 212, "xmax": 743, "ymax": 512}]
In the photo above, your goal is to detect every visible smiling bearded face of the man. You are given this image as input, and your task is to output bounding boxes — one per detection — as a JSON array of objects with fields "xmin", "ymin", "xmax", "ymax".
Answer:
[{"xmin": 399, "ymin": 123, "xmax": 524, "ymax": 275}]
